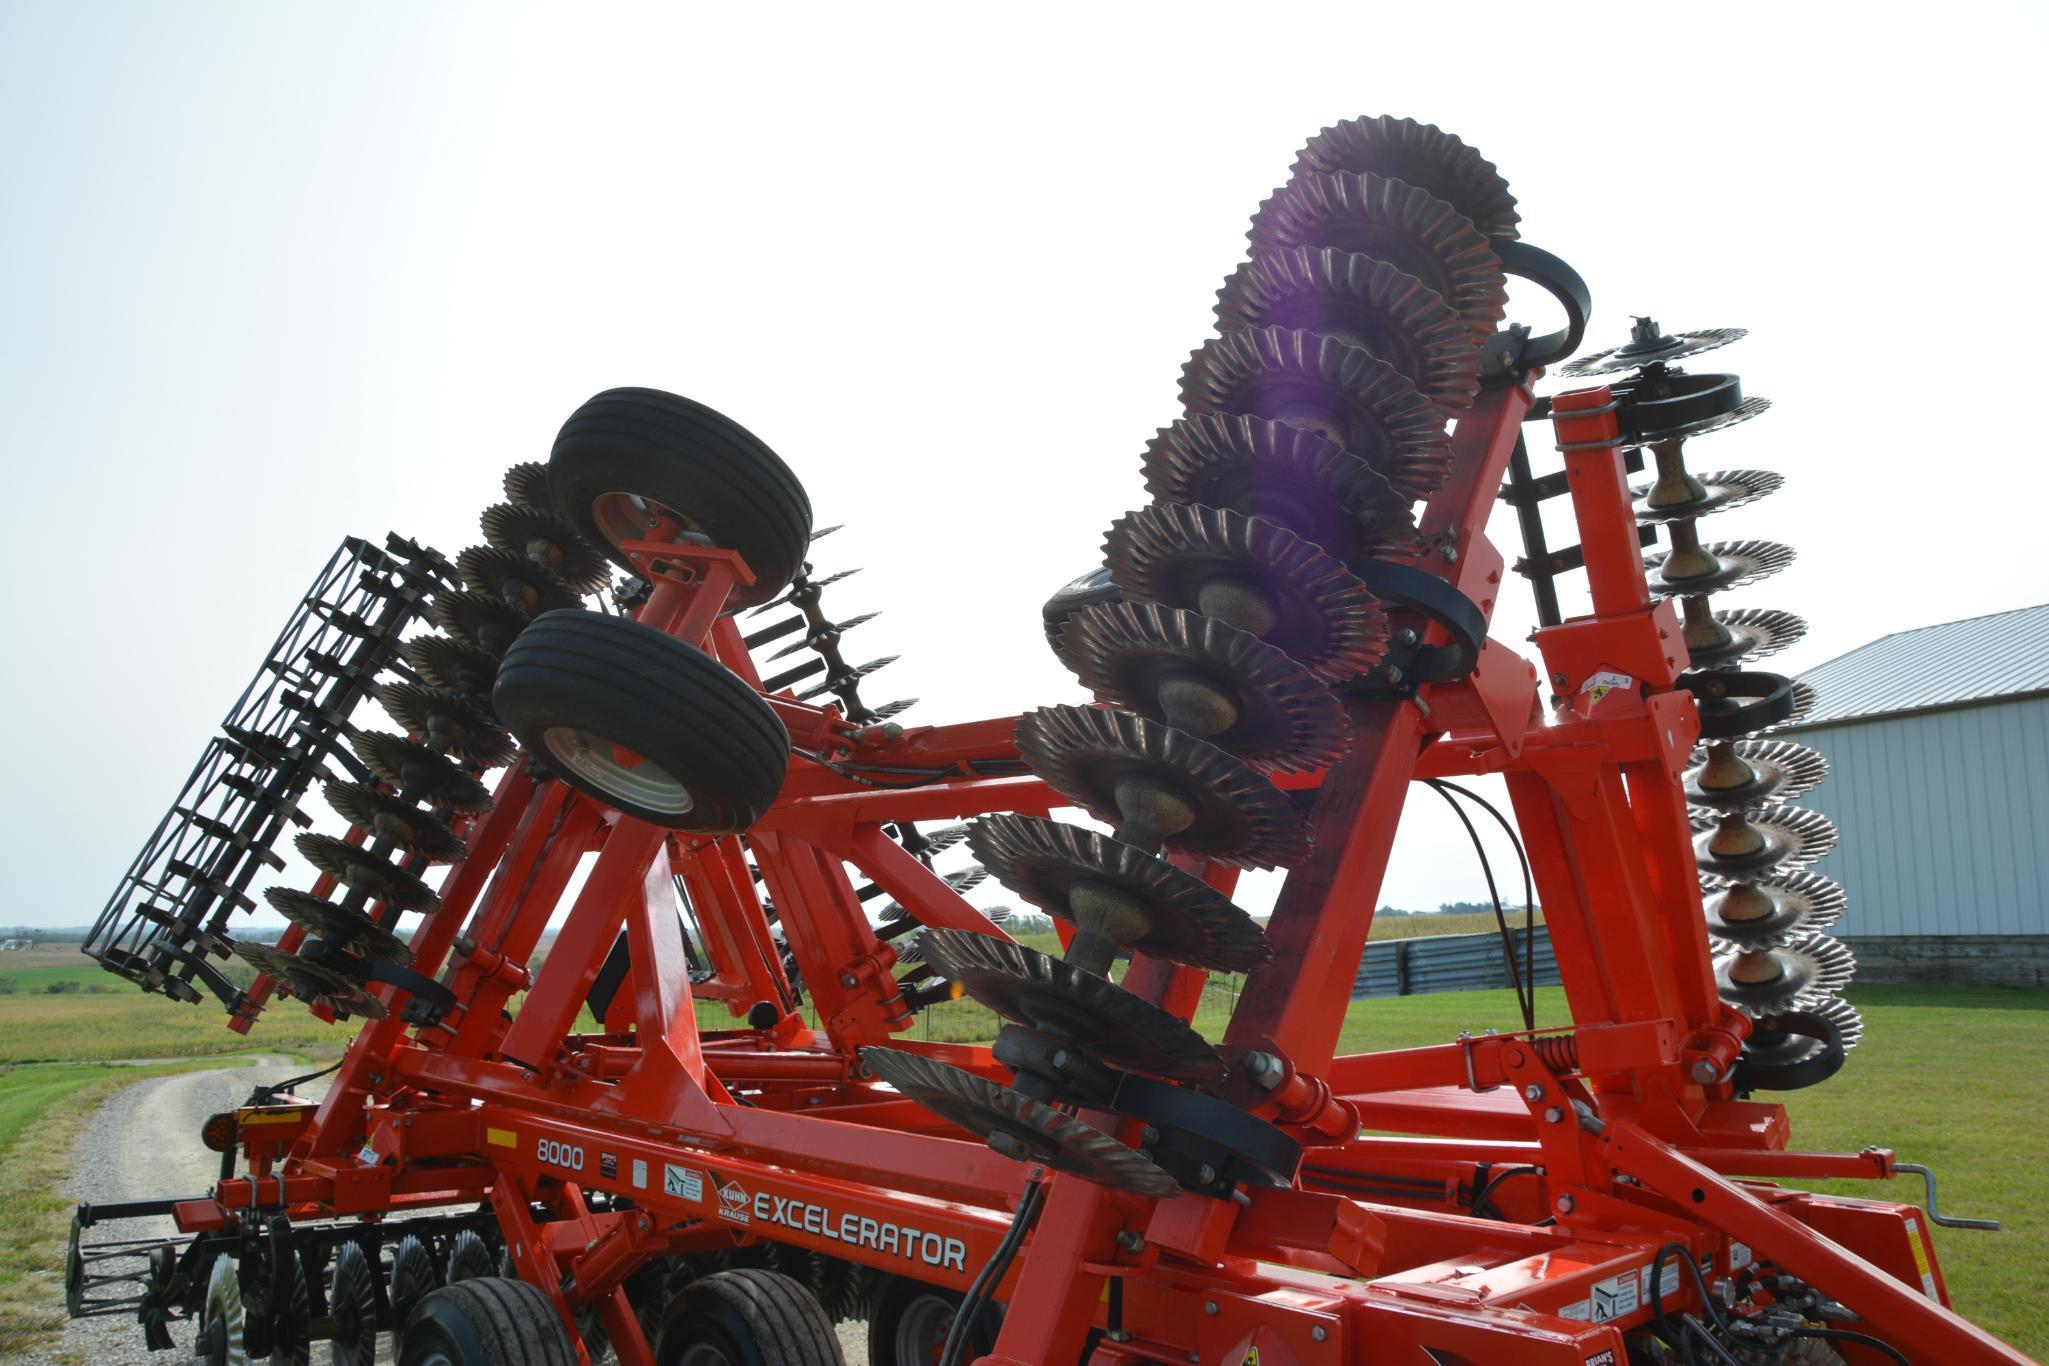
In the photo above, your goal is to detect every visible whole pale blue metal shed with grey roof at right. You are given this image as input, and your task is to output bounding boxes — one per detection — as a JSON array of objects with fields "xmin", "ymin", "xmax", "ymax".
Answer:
[{"xmin": 1781, "ymin": 604, "xmax": 2049, "ymax": 987}]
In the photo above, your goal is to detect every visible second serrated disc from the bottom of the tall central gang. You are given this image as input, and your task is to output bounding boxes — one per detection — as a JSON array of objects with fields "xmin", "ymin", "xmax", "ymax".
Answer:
[{"xmin": 920, "ymin": 930, "xmax": 1227, "ymax": 1083}]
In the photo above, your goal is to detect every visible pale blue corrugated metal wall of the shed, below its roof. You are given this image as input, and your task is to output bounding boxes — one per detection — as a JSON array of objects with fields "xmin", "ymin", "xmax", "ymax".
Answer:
[{"xmin": 1787, "ymin": 698, "xmax": 2049, "ymax": 936}]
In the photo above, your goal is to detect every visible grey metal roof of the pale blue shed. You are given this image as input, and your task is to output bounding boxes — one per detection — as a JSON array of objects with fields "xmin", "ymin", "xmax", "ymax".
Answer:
[{"xmin": 1787, "ymin": 602, "xmax": 2049, "ymax": 729}]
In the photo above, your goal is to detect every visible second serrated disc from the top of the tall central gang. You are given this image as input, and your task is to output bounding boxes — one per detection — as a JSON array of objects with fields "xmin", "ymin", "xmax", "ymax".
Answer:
[{"xmin": 1246, "ymin": 172, "xmax": 1508, "ymax": 340}]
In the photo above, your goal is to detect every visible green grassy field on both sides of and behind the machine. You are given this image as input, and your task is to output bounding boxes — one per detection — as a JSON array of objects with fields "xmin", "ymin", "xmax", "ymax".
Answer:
[{"xmin": 0, "ymin": 946, "xmax": 2049, "ymax": 1360}]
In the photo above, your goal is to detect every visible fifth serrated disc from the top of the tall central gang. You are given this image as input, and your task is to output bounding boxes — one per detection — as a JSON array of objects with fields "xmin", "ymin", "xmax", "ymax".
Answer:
[{"xmin": 1145, "ymin": 414, "xmax": 1418, "ymax": 559}]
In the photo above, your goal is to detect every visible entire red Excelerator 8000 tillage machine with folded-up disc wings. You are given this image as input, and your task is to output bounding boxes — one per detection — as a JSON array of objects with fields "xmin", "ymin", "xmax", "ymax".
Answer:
[{"xmin": 68, "ymin": 119, "xmax": 2022, "ymax": 1366}]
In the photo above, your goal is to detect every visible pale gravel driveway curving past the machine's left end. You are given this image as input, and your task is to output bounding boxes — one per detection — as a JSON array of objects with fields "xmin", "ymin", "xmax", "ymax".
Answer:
[{"xmin": 8, "ymin": 1059, "xmax": 867, "ymax": 1366}]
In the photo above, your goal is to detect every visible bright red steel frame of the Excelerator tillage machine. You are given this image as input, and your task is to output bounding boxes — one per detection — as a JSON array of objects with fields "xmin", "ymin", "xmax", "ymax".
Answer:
[{"xmin": 199, "ymin": 376, "xmax": 2026, "ymax": 1366}]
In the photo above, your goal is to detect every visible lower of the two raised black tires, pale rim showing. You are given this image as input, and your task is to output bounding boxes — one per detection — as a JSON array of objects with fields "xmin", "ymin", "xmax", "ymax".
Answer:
[{"xmin": 492, "ymin": 610, "xmax": 789, "ymax": 836}]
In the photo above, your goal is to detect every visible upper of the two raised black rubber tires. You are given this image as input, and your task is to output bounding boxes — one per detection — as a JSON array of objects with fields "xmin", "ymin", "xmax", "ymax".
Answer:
[{"xmin": 547, "ymin": 389, "xmax": 811, "ymax": 608}]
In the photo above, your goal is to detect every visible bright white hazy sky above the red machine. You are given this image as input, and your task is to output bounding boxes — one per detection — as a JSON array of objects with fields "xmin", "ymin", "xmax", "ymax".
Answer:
[{"xmin": 0, "ymin": 0, "xmax": 2049, "ymax": 924}]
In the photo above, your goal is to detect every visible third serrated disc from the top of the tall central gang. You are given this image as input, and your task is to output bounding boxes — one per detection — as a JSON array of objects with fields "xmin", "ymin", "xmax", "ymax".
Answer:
[{"xmin": 1217, "ymin": 246, "xmax": 1479, "ymax": 414}]
